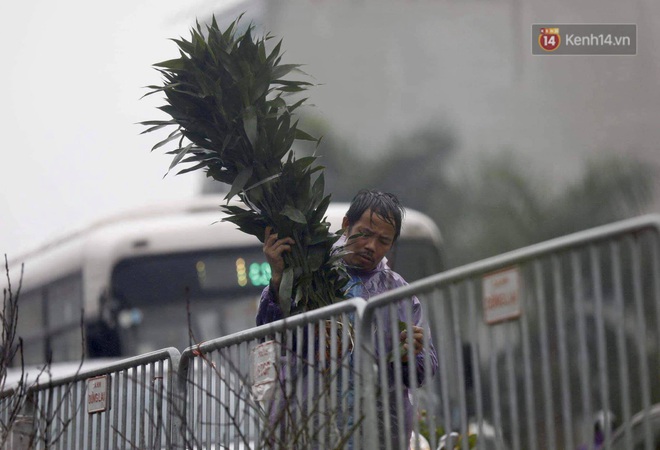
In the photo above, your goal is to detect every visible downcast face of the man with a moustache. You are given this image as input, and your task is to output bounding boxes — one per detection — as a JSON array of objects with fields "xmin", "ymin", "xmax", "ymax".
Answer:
[{"xmin": 342, "ymin": 210, "xmax": 395, "ymax": 270}]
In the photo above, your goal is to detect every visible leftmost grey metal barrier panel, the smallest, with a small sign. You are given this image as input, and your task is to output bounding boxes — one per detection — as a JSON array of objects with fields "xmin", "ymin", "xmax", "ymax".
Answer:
[{"xmin": 2, "ymin": 348, "xmax": 180, "ymax": 449}]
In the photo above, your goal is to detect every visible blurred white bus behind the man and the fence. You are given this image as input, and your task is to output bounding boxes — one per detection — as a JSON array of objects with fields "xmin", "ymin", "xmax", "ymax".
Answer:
[{"xmin": 10, "ymin": 195, "xmax": 442, "ymax": 365}]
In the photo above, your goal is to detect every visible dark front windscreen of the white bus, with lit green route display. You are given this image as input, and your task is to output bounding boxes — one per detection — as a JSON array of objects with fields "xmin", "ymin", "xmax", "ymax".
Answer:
[{"xmin": 111, "ymin": 246, "xmax": 270, "ymax": 354}]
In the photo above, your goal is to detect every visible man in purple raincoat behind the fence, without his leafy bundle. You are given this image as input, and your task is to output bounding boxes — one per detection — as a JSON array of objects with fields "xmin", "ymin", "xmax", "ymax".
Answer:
[{"xmin": 256, "ymin": 190, "xmax": 438, "ymax": 448}]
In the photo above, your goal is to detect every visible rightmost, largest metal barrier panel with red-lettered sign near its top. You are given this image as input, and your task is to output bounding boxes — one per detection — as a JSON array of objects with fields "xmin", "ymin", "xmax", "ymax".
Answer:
[{"xmin": 360, "ymin": 217, "xmax": 660, "ymax": 450}]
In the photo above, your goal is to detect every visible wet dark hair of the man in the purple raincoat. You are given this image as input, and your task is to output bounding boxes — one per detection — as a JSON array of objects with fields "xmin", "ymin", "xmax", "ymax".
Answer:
[{"xmin": 346, "ymin": 189, "xmax": 406, "ymax": 240}]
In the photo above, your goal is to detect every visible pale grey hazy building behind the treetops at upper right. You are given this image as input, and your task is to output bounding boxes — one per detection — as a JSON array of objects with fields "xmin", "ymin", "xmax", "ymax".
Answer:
[{"xmin": 246, "ymin": 0, "xmax": 660, "ymax": 186}]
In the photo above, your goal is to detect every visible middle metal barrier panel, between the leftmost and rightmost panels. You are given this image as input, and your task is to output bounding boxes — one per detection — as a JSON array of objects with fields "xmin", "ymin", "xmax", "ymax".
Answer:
[{"xmin": 179, "ymin": 299, "xmax": 364, "ymax": 449}]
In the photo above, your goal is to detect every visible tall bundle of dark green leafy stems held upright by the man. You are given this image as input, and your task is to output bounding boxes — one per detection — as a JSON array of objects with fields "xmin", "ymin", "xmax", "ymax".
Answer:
[{"xmin": 142, "ymin": 17, "xmax": 348, "ymax": 315}]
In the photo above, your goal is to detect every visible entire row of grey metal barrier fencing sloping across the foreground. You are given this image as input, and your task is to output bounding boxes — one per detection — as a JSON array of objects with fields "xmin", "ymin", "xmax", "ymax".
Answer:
[{"xmin": 0, "ymin": 216, "xmax": 660, "ymax": 450}]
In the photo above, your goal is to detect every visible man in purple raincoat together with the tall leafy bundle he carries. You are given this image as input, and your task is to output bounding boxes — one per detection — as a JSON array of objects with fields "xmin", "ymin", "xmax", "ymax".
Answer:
[{"xmin": 142, "ymin": 17, "xmax": 437, "ymax": 448}]
